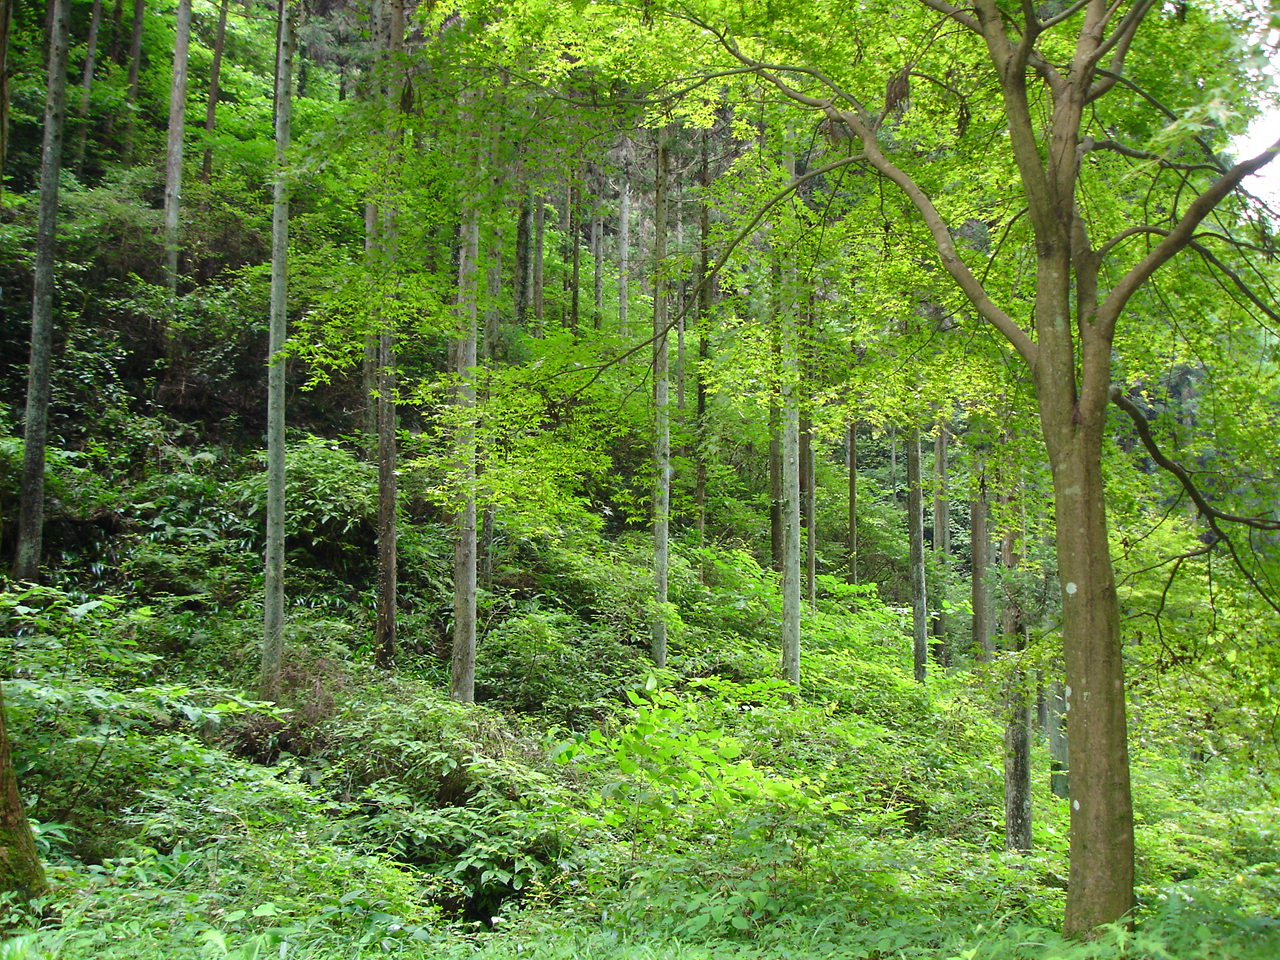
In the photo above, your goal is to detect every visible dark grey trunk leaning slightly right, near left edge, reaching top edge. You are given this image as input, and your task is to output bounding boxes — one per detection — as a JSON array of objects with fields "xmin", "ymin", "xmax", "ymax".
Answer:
[{"xmin": 13, "ymin": 0, "xmax": 69, "ymax": 580}]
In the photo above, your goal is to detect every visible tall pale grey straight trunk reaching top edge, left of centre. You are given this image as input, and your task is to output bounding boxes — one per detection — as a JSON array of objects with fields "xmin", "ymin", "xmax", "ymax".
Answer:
[{"xmin": 259, "ymin": 0, "xmax": 293, "ymax": 701}]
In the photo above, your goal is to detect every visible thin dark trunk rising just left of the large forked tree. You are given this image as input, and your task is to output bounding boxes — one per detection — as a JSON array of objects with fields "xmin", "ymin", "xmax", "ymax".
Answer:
[{"xmin": 1000, "ymin": 479, "xmax": 1032, "ymax": 852}]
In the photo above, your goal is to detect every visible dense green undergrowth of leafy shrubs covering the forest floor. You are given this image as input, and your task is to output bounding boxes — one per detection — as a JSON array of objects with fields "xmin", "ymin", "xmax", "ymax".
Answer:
[{"xmin": 0, "ymin": 439, "xmax": 1280, "ymax": 960}]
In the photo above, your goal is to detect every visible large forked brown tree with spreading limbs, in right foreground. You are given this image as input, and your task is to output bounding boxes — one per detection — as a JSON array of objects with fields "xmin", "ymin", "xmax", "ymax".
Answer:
[{"xmin": 682, "ymin": 0, "xmax": 1280, "ymax": 936}]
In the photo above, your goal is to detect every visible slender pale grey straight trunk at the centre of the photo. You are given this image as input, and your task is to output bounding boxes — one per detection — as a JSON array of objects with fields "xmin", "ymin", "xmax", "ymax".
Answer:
[{"xmin": 650, "ymin": 131, "xmax": 671, "ymax": 667}]
